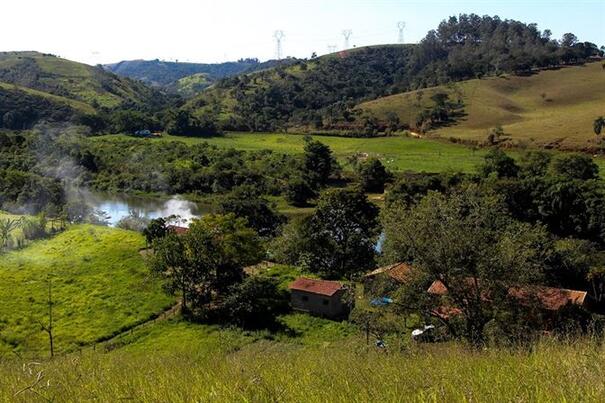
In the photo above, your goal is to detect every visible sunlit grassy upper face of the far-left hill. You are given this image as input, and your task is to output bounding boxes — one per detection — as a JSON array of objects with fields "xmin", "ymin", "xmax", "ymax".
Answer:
[{"xmin": 0, "ymin": 52, "xmax": 158, "ymax": 108}]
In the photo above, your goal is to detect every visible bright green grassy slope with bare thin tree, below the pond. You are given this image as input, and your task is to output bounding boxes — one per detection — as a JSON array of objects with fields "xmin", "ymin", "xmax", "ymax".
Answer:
[{"xmin": 0, "ymin": 225, "xmax": 173, "ymax": 351}]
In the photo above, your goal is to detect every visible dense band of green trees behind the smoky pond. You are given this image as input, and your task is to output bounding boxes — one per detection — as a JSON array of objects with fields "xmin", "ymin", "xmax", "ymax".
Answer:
[{"xmin": 0, "ymin": 126, "xmax": 340, "ymax": 221}]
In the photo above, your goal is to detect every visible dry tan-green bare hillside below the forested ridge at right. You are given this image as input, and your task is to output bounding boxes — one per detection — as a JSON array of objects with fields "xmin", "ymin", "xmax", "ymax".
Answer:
[{"xmin": 358, "ymin": 63, "xmax": 605, "ymax": 149}]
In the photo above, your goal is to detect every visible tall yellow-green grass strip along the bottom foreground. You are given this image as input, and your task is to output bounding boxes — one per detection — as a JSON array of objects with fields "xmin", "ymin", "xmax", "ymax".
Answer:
[{"xmin": 0, "ymin": 340, "xmax": 605, "ymax": 402}]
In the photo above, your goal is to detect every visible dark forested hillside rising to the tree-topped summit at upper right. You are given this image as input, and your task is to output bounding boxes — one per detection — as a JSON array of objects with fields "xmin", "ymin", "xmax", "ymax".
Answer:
[{"xmin": 187, "ymin": 14, "xmax": 602, "ymax": 134}]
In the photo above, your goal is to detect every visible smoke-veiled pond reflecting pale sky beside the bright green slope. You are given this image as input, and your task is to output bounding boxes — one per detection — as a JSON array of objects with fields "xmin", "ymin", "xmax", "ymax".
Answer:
[{"xmin": 87, "ymin": 193, "xmax": 209, "ymax": 226}]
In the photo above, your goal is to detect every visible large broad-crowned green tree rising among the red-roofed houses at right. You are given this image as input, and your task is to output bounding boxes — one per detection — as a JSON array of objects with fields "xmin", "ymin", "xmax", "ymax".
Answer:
[{"xmin": 384, "ymin": 186, "xmax": 552, "ymax": 343}]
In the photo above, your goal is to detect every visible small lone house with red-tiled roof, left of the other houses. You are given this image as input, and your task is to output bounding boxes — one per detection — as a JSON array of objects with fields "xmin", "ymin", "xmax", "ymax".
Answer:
[{"xmin": 289, "ymin": 277, "xmax": 349, "ymax": 318}]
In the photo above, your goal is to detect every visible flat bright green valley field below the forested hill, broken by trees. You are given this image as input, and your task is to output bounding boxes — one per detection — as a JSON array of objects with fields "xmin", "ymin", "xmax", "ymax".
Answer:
[{"xmin": 92, "ymin": 133, "xmax": 605, "ymax": 173}]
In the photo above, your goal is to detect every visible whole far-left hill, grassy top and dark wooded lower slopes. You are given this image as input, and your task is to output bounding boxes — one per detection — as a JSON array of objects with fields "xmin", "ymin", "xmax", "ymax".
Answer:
[{"xmin": 0, "ymin": 52, "xmax": 176, "ymax": 132}]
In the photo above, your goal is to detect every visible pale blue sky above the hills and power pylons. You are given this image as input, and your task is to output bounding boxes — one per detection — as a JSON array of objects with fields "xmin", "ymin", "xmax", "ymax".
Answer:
[{"xmin": 0, "ymin": 0, "xmax": 605, "ymax": 64}]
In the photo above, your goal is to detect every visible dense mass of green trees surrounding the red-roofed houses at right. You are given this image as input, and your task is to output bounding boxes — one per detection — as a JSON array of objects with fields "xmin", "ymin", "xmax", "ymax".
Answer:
[{"xmin": 382, "ymin": 149, "xmax": 605, "ymax": 344}]
